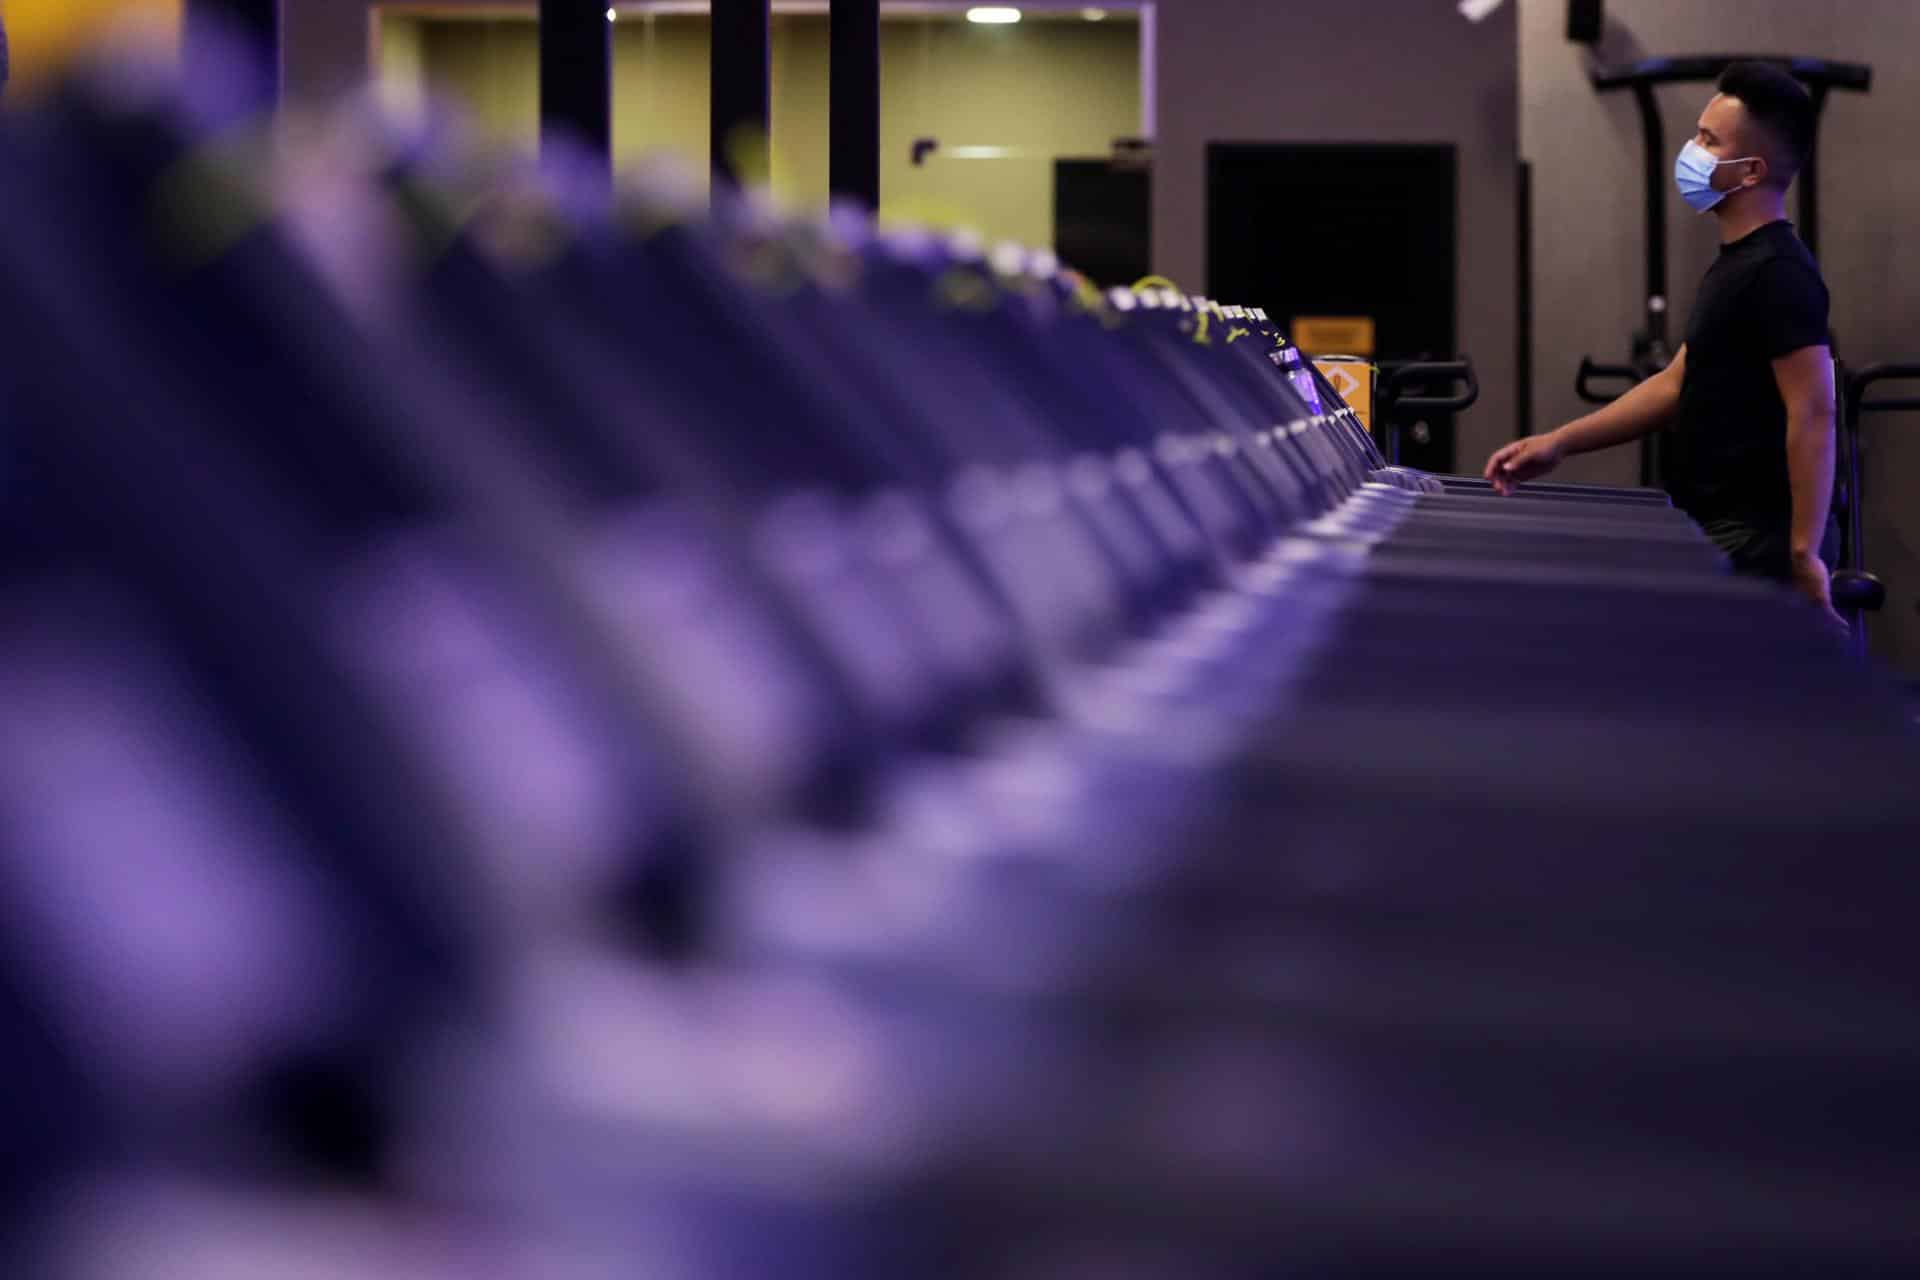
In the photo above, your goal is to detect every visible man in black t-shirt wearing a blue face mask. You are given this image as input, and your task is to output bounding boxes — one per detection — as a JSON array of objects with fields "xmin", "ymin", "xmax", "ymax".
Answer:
[{"xmin": 1486, "ymin": 61, "xmax": 1839, "ymax": 624}]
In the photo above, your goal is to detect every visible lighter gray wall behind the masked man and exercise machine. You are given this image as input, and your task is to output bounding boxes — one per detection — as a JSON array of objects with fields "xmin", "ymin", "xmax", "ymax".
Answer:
[{"xmin": 1521, "ymin": 0, "xmax": 1920, "ymax": 672}]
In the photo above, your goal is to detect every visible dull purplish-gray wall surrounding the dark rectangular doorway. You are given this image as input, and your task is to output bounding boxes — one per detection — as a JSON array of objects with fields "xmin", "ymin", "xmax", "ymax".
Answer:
[{"xmin": 1154, "ymin": 0, "xmax": 1519, "ymax": 477}]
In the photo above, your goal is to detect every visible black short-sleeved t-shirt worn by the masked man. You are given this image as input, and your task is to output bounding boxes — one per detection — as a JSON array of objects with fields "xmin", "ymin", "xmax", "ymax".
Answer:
[{"xmin": 1665, "ymin": 223, "xmax": 1832, "ymax": 535}]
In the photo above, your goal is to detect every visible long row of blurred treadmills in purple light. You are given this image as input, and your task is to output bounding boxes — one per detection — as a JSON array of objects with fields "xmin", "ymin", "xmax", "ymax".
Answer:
[{"xmin": 11, "ymin": 40, "xmax": 1920, "ymax": 1280}]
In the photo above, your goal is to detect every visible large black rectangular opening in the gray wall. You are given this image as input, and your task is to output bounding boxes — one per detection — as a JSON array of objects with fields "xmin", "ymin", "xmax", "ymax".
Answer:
[{"xmin": 1206, "ymin": 142, "xmax": 1457, "ymax": 472}]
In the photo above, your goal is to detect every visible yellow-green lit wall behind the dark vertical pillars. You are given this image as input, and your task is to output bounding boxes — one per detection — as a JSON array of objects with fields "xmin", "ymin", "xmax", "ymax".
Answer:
[{"xmin": 380, "ymin": 13, "xmax": 1140, "ymax": 253}]
